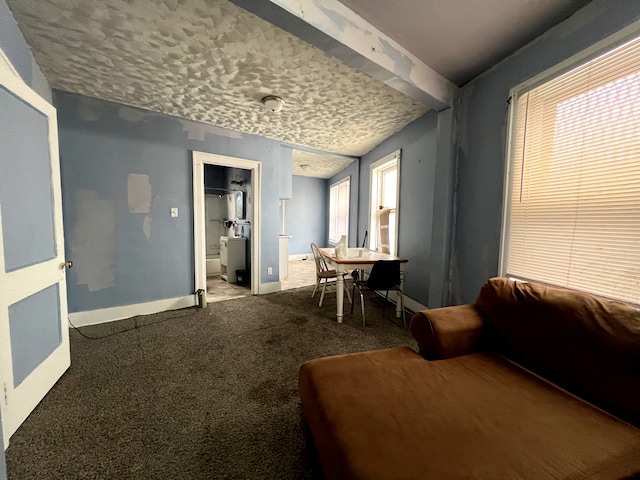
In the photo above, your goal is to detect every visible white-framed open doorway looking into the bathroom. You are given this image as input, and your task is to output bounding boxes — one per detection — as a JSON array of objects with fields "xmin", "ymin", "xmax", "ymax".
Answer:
[{"xmin": 193, "ymin": 152, "xmax": 261, "ymax": 302}]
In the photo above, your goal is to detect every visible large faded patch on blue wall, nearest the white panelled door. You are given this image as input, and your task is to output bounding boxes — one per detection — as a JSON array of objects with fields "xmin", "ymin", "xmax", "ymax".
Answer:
[{"xmin": 71, "ymin": 190, "xmax": 116, "ymax": 292}]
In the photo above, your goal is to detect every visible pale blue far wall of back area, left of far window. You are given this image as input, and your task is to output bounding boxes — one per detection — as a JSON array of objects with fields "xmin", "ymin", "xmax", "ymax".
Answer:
[{"xmin": 284, "ymin": 175, "xmax": 328, "ymax": 255}]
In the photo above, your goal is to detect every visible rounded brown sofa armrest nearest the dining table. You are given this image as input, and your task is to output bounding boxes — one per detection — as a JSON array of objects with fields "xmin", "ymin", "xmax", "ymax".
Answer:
[{"xmin": 411, "ymin": 305, "xmax": 484, "ymax": 360}]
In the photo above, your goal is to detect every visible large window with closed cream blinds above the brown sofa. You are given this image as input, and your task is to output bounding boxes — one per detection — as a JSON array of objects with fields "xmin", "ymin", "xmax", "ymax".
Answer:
[{"xmin": 502, "ymin": 32, "xmax": 640, "ymax": 304}]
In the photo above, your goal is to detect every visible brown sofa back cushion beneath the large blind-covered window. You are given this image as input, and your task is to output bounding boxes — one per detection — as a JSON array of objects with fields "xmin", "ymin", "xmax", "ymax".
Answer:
[{"xmin": 476, "ymin": 278, "xmax": 640, "ymax": 427}]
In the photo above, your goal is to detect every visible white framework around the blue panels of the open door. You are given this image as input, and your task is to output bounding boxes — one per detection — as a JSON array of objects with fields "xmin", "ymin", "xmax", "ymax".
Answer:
[{"xmin": 0, "ymin": 49, "xmax": 71, "ymax": 448}]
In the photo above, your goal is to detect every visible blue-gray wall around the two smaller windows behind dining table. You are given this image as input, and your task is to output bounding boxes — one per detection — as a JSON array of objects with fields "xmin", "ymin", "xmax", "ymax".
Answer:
[{"xmin": 342, "ymin": 110, "xmax": 455, "ymax": 307}]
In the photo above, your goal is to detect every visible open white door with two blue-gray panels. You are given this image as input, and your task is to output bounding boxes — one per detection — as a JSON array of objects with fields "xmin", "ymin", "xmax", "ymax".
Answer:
[{"xmin": 0, "ymin": 50, "xmax": 70, "ymax": 448}]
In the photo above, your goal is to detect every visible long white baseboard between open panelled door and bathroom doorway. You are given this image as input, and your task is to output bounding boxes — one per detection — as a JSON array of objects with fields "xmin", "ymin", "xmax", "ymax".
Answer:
[{"xmin": 69, "ymin": 295, "xmax": 198, "ymax": 327}]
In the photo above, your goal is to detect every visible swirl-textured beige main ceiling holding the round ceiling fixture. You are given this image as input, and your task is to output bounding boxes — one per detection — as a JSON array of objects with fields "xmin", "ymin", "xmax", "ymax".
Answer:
[{"xmin": 8, "ymin": 0, "xmax": 426, "ymax": 167}]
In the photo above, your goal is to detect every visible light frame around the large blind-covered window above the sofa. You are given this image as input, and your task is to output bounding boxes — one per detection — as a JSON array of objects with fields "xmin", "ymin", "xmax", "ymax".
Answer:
[{"xmin": 498, "ymin": 21, "xmax": 640, "ymax": 306}]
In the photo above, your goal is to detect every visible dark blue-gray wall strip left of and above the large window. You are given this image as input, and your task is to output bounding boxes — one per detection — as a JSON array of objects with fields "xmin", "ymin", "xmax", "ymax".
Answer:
[{"xmin": 452, "ymin": 0, "xmax": 640, "ymax": 303}]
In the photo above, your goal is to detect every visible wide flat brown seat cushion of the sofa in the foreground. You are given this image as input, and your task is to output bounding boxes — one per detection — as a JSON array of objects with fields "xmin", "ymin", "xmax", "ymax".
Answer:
[{"xmin": 299, "ymin": 348, "xmax": 640, "ymax": 479}]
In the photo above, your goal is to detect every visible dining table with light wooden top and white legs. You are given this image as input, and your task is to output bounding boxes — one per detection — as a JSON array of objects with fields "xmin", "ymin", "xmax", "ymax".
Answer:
[{"xmin": 318, "ymin": 248, "xmax": 409, "ymax": 323}]
